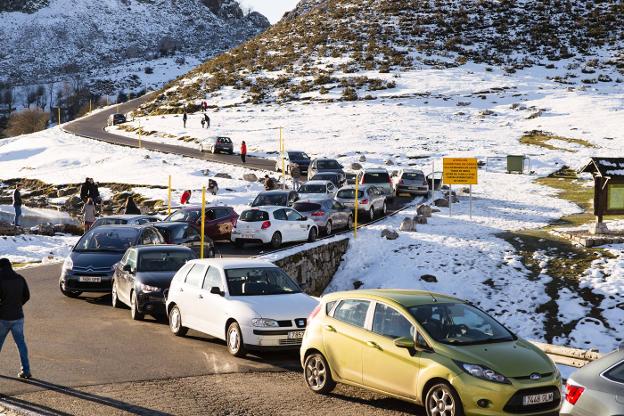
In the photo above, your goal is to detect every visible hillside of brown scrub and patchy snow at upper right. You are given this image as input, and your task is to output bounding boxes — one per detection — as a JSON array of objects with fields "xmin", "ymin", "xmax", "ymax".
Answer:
[{"xmin": 148, "ymin": 0, "xmax": 624, "ymax": 112}]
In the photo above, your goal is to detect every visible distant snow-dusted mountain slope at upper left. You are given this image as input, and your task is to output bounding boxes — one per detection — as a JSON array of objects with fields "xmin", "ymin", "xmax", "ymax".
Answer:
[{"xmin": 0, "ymin": 0, "xmax": 269, "ymax": 94}]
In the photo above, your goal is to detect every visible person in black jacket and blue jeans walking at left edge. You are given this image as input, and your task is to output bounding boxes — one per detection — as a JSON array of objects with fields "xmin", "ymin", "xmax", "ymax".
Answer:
[{"xmin": 0, "ymin": 258, "xmax": 32, "ymax": 379}]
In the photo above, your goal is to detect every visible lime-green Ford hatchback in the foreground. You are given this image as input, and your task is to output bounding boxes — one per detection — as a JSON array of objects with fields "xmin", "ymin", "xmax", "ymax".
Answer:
[{"xmin": 301, "ymin": 290, "xmax": 561, "ymax": 416}]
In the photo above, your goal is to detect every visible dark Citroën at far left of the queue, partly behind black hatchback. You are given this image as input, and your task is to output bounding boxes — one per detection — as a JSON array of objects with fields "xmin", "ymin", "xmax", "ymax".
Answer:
[{"xmin": 59, "ymin": 225, "xmax": 165, "ymax": 298}]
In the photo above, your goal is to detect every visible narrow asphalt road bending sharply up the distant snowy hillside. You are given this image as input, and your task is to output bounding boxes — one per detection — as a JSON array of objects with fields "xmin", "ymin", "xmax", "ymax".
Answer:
[{"xmin": 63, "ymin": 93, "xmax": 275, "ymax": 171}]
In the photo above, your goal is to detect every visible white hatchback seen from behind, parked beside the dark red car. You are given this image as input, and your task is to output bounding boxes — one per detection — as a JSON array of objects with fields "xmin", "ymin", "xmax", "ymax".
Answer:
[{"xmin": 231, "ymin": 206, "xmax": 318, "ymax": 248}]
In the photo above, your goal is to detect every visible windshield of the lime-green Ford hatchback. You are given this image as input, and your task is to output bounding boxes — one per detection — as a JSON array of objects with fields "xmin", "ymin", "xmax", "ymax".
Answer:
[{"xmin": 408, "ymin": 303, "xmax": 516, "ymax": 345}]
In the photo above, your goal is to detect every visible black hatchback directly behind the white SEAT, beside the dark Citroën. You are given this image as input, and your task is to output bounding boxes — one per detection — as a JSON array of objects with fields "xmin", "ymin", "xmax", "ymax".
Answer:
[{"xmin": 112, "ymin": 245, "xmax": 196, "ymax": 321}]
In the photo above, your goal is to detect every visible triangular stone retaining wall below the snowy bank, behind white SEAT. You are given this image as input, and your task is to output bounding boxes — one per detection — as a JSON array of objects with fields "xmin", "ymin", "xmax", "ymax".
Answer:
[{"xmin": 266, "ymin": 237, "xmax": 349, "ymax": 296}]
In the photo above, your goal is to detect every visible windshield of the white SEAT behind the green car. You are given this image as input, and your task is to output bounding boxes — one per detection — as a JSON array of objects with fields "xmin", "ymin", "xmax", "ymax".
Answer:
[{"xmin": 225, "ymin": 267, "xmax": 301, "ymax": 296}]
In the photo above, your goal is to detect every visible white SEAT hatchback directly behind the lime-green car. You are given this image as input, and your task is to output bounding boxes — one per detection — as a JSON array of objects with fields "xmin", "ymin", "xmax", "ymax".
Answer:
[{"xmin": 167, "ymin": 259, "xmax": 318, "ymax": 357}]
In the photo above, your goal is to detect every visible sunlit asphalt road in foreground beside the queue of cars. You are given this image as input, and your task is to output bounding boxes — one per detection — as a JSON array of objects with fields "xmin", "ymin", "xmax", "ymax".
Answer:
[{"xmin": 0, "ymin": 264, "xmax": 421, "ymax": 416}]
